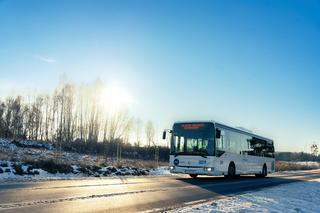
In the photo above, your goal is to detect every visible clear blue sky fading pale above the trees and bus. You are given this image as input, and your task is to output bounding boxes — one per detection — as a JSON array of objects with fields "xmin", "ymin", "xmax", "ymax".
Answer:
[{"xmin": 0, "ymin": 0, "xmax": 320, "ymax": 151}]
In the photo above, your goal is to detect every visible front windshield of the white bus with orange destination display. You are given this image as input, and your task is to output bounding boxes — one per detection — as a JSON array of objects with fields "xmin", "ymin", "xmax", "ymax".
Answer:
[{"xmin": 170, "ymin": 123, "xmax": 214, "ymax": 157}]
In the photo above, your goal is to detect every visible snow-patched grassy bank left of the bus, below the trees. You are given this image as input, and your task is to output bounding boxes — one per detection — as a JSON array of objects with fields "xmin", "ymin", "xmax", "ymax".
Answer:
[{"xmin": 0, "ymin": 138, "xmax": 170, "ymax": 183}]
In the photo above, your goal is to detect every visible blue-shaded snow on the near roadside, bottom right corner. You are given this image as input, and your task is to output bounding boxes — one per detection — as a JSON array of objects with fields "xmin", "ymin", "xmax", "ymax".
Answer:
[{"xmin": 170, "ymin": 179, "xmax": 320, "ymax": 213}]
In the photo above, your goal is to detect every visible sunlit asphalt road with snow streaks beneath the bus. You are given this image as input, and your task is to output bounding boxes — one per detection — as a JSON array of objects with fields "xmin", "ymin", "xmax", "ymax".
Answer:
[{"xmin": 0, "ymin": 170, "xmax": 320, "ymax": 212}]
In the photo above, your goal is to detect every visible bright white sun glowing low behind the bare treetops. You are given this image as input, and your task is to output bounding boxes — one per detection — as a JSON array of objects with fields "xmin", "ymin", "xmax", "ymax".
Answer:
[{"xmin": 99, "ymin": 85, "xmax": 133, "ymax": 110}]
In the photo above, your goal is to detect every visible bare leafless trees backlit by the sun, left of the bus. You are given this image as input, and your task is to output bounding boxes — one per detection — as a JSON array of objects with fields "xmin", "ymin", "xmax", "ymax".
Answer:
[{"xmin": 0, "ymin": 81, "xmax": 156, "ymax": 150}]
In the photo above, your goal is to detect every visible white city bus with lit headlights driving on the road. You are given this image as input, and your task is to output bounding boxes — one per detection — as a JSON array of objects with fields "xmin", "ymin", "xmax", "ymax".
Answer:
[{"xmin": 163, "ymin": 121, "xmax": 275, "ymax": 178}]
